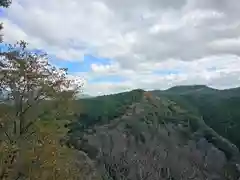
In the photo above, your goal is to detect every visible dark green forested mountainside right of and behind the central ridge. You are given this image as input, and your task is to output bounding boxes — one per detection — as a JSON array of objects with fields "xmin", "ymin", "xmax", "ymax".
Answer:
[{"xmin": 152, "ymin": 86, "xmax": 240, "ymax": 147}]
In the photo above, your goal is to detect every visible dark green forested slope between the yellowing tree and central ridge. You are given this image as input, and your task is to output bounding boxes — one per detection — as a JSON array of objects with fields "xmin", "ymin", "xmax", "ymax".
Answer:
[{"xmin": 69, "ymin": 90, "xmax": 143, "ymax": 130}]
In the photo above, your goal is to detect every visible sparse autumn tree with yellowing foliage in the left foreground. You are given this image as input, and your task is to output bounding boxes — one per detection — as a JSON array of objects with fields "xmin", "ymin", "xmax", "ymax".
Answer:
[{"xmin": 0, "ymin": 42, "xmax": 99, "ymax": 180}]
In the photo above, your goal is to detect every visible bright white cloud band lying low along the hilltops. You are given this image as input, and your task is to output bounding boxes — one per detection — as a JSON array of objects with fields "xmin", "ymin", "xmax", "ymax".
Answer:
[{"xmin": 73, "ymin": 55, "xmax": 240, "ymax": 95}]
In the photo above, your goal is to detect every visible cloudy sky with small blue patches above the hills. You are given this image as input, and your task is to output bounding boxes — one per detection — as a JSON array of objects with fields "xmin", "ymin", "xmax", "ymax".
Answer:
[{"xmin": 0, "ymin": 0, "xmax": 240, "ymax": 95}]
